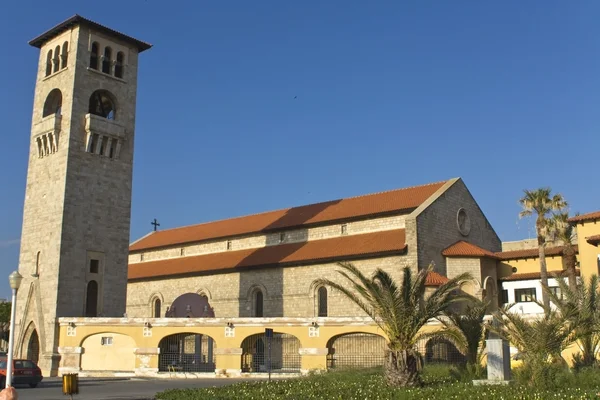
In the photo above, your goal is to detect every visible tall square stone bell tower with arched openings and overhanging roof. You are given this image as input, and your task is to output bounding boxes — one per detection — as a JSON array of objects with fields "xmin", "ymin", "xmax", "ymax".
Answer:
[{"xmin": 15, "ymin": 15, "xmax": 151, "ymax": 376}]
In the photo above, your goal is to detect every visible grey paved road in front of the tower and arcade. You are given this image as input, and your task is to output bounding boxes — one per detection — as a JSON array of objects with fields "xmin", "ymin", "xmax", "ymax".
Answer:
[{"xmin": 15, "ymin": 378, "xmax": 255, "ymax": 400}]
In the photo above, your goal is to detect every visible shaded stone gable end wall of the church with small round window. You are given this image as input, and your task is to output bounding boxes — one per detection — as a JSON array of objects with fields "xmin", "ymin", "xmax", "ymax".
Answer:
[{"xmin": 416, "ymin": 179, "xmax": 501, "ymax": 276}]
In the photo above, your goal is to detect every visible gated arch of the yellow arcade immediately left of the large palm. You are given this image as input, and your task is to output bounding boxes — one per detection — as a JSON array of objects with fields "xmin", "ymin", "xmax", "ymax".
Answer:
[{"xmin": 327, "ymin": 333, "xmax": 386, "ymax": 368}]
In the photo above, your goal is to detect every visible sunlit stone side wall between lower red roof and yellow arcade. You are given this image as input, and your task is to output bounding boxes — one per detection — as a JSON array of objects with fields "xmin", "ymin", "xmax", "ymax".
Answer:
[{"xmin": 127, "ymin": 256, "xmax": 410, "ymax": 317}]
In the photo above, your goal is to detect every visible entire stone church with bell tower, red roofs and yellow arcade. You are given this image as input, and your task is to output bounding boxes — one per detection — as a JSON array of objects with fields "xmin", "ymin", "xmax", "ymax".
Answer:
[{"xmin": 14, "ymin": 15, "xmax": 600, "ymax": 377}]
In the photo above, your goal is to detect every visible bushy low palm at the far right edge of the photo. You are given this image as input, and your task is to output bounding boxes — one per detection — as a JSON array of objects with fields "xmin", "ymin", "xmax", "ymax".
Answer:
[{"xmin": 543, "ymin": 275, "xmax": 600, "ymax": 366}]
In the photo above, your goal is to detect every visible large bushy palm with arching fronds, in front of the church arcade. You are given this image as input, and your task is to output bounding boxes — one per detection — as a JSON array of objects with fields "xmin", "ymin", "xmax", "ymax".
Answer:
[{"xmin": 313, "ymin": 263, "xmax": 471, "ymax": 386}]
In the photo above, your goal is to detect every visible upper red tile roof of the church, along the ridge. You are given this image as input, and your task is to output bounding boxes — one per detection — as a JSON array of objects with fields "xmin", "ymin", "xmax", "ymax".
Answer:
[{"xmin": 129, "ymin": 182, "xmax": 446, "ymax": 251}]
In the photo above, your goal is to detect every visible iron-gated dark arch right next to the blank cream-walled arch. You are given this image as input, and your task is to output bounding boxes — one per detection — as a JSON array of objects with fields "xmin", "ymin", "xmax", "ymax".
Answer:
[{"xmin": 158, "ymin": 333, "xmax": 216, "ymax": 372}]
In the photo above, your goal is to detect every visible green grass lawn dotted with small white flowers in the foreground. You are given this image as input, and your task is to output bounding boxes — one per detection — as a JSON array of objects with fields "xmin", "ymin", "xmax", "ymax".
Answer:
[{"xmin": 156, "ymin": 367, "xmax": 600, "ymax": 400}]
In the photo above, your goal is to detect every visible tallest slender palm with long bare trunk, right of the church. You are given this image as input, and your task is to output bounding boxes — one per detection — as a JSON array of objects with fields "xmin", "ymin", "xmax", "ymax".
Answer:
[{"xmin": 519, "ymin": 188, "xmax": 567, "ymax": 310}]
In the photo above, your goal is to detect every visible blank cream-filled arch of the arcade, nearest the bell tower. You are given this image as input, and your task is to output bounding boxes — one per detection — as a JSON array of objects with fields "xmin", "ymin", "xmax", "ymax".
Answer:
[{"xmin": 81, "ymin": 331, "xmax": 137, "ymax": 372}]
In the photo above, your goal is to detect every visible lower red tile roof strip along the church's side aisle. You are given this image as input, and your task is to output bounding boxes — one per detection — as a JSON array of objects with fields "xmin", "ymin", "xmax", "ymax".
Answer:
[{"xmin": 128, "ymin": 229, "xmax": 406, "ymax": 279}]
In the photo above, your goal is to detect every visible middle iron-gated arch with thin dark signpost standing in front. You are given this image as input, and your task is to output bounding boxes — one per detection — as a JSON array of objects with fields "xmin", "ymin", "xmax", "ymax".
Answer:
[{"xmin": 242, "ymin": 332, "xmax": 301, "ymax": 373}]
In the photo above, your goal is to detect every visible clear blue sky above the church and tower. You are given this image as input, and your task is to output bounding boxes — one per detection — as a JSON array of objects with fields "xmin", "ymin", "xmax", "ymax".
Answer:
[{"xmin": 0, "ymin": 0, "xmax": 600, "ymax": 297}]
